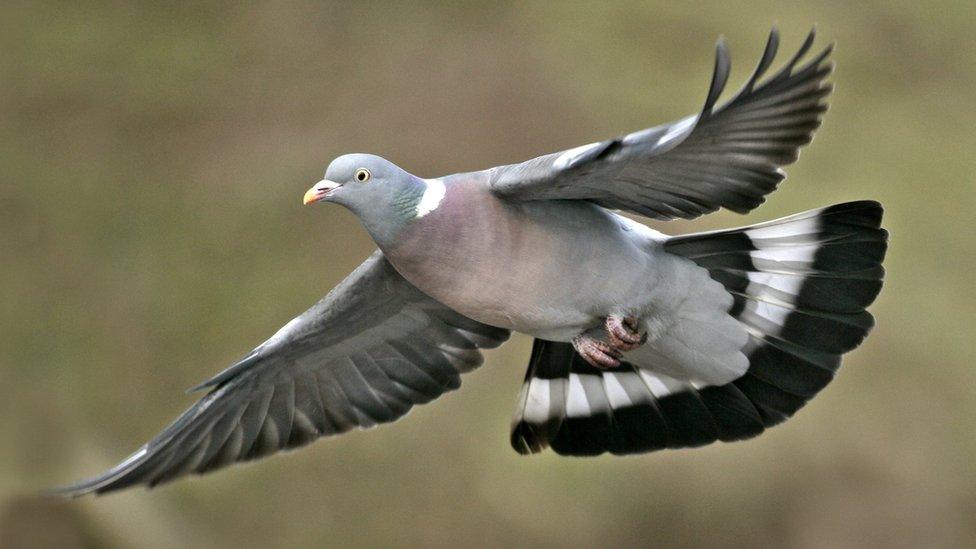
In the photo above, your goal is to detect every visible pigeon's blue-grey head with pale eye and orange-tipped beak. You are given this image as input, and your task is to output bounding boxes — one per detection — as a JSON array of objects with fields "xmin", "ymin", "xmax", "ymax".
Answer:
[{"xmin": 304, "ymin": 154, "xmax": 427, "ymax": 247}]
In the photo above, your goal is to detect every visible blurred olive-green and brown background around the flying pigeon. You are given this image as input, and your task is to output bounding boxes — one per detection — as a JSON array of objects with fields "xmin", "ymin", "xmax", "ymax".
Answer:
[{"xmin": 0, "ymin": 0, "xmax": 976, "ymax": 547}]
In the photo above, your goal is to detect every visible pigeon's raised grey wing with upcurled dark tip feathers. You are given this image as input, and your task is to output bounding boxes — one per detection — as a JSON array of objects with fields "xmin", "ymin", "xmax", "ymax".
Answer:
[{"xmin": 489, "ymin": 28, "xmax": 832, "ymax": 219}]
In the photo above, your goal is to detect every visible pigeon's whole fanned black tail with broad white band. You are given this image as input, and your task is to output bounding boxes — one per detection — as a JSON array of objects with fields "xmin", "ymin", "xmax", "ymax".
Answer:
[{"xmin": 512, "ymin": 201, "xmax": 888, "ymax": 455}]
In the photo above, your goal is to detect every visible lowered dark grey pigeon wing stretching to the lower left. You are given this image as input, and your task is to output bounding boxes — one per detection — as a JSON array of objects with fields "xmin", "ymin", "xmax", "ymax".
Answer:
[{"xmin": 55, "ymin": 251, "xmax": 509, "ymax": 496}]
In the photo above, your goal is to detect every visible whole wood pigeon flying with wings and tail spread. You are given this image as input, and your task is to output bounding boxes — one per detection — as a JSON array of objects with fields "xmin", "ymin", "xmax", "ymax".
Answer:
[{"xmin": 58, "ymin": 28, "xmax": 887, "ymax": 496}]
